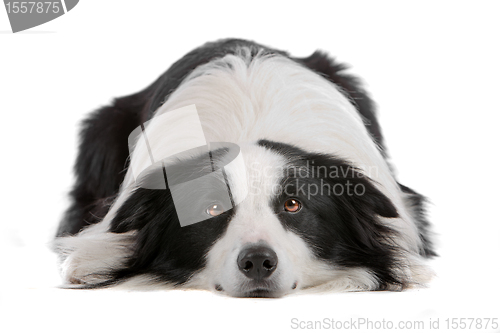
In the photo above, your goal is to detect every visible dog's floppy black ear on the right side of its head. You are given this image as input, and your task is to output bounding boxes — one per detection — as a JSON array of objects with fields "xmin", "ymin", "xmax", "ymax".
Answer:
[{"xmin": 322, "ymin": 167, "xmax": 404, "ymax": 290}]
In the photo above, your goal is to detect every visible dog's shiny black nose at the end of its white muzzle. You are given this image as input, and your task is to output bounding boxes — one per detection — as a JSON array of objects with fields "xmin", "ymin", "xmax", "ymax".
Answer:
[{"xmin": 238, "ymin": 245, "xmax": 278, "ymax": 280}]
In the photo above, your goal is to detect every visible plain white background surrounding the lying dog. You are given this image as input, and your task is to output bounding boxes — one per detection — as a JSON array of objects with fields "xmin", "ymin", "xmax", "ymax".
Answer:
[{"xmin": 0, "ymin": 0, "xmax": 500, "ymax": 332}]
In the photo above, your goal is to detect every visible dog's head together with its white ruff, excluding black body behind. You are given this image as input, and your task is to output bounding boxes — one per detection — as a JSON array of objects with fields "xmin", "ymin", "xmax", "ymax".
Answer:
[{"xmin": 56, "ymin": 41, "xmax": 434, "ymax": 297}]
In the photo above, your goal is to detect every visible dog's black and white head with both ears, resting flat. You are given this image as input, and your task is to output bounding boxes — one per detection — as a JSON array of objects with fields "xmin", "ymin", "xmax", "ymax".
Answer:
[{"xmin": 55, "ymin": 140, "xmax": 414, "ymax": 296}]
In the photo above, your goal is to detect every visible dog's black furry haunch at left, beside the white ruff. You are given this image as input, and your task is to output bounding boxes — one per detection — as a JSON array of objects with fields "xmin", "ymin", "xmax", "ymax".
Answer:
[{"xmin": 56, "ymin": 90, "xmax": 150, "ymax": 237}]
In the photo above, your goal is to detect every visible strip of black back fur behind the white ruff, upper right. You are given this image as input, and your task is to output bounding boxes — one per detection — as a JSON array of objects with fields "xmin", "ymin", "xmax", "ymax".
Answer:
[{"xmin": 293, "ymin": 51, "xmax": 384, "ymax": 151}]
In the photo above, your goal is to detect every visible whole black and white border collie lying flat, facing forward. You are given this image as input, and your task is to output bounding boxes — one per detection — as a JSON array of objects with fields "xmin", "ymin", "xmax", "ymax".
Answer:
[{"xmin": 54, "ymin": 39, "xmax": 435, "ymax": 297}]
